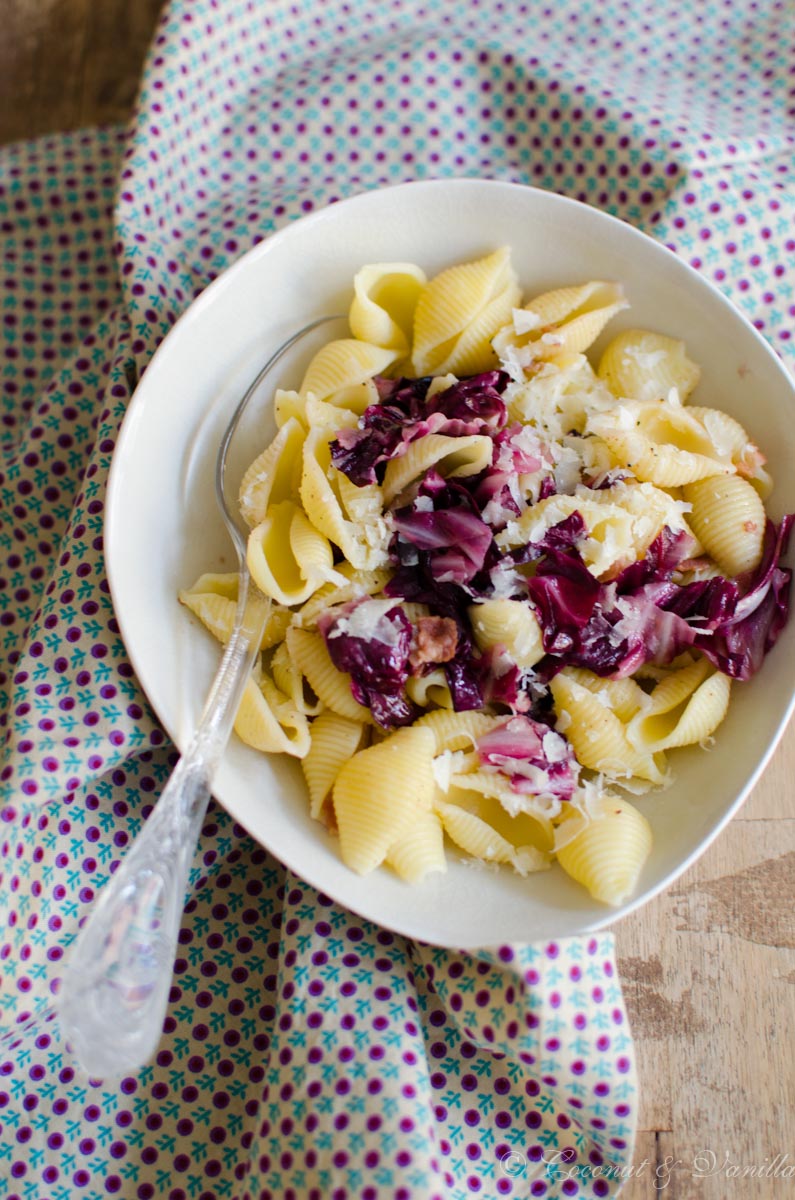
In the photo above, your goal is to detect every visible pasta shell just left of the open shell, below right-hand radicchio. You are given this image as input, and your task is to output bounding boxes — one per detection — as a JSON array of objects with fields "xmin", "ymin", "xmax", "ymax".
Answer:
[{"xmin": 550, "ymin": 671, "xmax": 664, "ymax": 784}]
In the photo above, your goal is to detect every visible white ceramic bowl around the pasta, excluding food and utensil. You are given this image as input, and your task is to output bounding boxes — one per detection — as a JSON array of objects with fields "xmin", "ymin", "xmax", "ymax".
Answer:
[{"xmin": 106, "ymin": 180, "xmax": 795, "ymax": 948}]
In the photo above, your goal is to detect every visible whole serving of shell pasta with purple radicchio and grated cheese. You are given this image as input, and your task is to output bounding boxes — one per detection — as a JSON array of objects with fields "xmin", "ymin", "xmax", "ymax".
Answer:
[{"xmin": 179, "ymin": 247, "xmax": 794, "ymax": 905}]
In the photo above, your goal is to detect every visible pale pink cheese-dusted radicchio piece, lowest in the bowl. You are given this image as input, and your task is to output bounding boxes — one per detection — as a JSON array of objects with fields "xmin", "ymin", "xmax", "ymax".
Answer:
[{"xmin": 477, "ymin": 716, "xmax": 578, "ymax": 800}]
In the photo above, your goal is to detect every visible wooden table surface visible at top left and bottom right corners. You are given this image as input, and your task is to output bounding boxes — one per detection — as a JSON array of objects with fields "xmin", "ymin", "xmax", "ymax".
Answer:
[{"xmin": 0, "ymin": 0, "xmax": 795, "ymax": 1200}]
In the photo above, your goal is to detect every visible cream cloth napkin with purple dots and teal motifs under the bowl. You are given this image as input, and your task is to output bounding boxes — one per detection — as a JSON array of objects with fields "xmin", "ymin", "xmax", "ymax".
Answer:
[{"xmin": 0, "ymin": 0, "xmax": 795, "ymax": 1200}]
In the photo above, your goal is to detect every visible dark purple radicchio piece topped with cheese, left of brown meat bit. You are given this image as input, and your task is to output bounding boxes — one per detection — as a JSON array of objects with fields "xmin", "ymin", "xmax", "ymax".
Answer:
[{"xmin": 318, "ymin": 599, "xmax": 418, "ymax": 730}]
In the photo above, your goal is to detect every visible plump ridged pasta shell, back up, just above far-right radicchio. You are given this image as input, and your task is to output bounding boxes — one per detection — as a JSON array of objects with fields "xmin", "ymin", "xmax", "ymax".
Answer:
[{"xmin": 685, "ymin": 475, "xmax": 765, "ymax": 575}]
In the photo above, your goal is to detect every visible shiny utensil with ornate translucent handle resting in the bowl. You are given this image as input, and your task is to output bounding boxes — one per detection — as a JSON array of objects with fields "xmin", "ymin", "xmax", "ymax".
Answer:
[{"xmin": 58, "ymin": 317, "xmax": 337, "ymax": 1079}]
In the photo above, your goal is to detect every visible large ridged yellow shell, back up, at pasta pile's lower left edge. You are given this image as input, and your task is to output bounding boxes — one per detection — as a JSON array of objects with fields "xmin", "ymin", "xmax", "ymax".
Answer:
[{"xmin": 333, "ymin": 728, "xmax": 435, "ymax": 875}]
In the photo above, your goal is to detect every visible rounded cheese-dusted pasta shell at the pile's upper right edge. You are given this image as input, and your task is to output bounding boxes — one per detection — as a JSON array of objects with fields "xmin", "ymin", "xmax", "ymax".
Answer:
[{"xmin": 598, "ymin": 329, "xmax": 701, "ymax": 401}]
